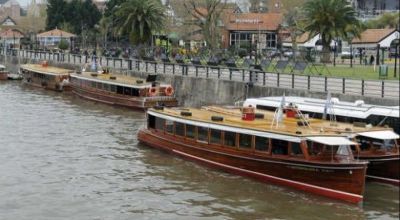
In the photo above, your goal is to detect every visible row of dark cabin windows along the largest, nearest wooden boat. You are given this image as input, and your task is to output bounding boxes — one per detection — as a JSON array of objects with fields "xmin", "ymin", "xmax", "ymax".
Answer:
[{"xmin": 148, "ymin": 115, "xmax": 303, "ymax": 156}]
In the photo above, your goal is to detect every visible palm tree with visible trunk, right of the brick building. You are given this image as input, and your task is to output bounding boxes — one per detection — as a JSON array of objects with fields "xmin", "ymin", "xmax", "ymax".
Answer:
[{"xmin": 303, "ymin": 0, "xmax": 361, "ymax": 62}]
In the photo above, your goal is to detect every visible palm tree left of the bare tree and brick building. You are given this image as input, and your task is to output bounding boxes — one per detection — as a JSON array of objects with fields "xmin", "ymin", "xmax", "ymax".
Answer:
[{"xmin": 114, "ymin": 0, "xmax": 165, "ymax": 44}]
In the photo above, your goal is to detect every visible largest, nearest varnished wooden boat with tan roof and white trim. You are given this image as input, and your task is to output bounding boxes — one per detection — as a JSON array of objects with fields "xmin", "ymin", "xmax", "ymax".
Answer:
[{"xmin": 138, "ymin": 107, "xmax": 368, "ymax": 203}]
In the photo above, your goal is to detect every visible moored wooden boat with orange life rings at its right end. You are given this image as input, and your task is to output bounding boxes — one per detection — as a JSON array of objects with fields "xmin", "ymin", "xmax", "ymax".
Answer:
[{"xmin": 70, "ymin": 71, "xmax": 178, "ymax": 109}]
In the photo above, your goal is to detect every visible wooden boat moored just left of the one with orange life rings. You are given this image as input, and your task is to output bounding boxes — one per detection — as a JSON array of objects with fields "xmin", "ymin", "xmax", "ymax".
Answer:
[{"xmin": 20, "ymin": 61, "xmax": 73, "ymax": 91}]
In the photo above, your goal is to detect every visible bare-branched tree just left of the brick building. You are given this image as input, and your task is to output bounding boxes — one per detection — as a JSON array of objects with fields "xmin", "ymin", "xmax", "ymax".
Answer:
[{"xmin": 185, "ymin": 0, "xmax": 227, "ymax": 51}]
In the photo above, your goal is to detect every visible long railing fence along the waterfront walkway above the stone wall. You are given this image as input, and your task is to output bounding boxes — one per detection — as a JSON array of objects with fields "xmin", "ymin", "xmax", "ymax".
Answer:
[{"xmin": 10, "ymin": 50, "xmax": 400, "ymax": 99}]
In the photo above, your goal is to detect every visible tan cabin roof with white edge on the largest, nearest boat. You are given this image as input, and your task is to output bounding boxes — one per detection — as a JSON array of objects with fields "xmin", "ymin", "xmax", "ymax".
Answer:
[{"xmin": 148, "ymin": 107, "xmax": 355, "ymax": 145}]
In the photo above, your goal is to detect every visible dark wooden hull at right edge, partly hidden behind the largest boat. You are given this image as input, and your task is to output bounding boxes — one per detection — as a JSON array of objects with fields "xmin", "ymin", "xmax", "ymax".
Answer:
[{"xmin": 359, "ymin": 155, "xmax": 400, "ymax": 186}]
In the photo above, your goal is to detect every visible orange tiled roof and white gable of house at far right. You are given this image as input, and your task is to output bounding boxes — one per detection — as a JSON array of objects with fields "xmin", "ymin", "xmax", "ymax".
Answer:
[{"xmin": 351, "ymin": 28, "xmax": 400, "ymax": 49}]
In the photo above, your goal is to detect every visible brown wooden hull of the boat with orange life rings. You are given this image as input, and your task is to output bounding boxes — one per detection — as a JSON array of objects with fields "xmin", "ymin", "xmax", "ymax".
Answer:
[{"xmin": 72, "ymin": 84, "xmax": 178, "ymax": 110}]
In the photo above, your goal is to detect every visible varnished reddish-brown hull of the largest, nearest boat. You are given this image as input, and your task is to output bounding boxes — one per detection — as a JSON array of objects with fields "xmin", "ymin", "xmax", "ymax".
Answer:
[{"xmin": 138, "ymin": 129, "xmax": 366, "ymax": 203}]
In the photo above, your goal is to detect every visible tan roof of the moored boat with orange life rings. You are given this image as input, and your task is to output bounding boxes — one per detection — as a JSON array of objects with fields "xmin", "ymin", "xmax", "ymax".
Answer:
[{"xmin": 71, "ymin": 72, "xmax": 169, "ymax": 89}]
